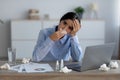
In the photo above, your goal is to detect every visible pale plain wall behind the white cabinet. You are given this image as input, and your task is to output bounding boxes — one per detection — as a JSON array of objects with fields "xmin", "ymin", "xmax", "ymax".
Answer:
[{"xmin": 0, "ymin": 0, "xmax": 119, "ymax": 58}]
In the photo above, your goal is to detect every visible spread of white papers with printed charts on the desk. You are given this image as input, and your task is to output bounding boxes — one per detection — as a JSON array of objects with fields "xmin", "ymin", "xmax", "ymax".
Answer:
[{"xmin": 11, "ymin": 62, "xmax": 54, "ymax": 73}]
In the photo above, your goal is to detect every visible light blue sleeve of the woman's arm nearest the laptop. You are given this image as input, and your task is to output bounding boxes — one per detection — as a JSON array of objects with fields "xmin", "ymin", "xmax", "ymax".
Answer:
[{"xmin": 70, "ymin": 36, "xmax": 83, "ymax": 61}]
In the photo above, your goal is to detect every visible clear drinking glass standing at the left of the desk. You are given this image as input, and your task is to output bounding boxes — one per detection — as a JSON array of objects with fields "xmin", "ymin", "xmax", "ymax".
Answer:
[{"xmin": 8, "ymin": 48, "xmax": 16, "ymax": 65}]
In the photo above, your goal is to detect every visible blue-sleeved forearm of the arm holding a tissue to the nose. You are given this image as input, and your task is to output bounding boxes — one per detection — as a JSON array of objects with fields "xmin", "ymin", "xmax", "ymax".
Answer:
[{"xmin": 33, "ymin": 37, "xmax": 54, "ymax": 61}]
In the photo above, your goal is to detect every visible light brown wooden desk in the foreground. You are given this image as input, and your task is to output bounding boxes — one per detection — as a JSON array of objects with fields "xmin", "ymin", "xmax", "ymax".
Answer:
[{"xmin": 0, "ymin": 61, "xmax": 120, "ymax": 80}]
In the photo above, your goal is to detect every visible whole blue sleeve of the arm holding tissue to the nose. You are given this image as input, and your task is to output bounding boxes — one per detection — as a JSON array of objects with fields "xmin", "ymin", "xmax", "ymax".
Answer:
[{"xmin": 32, "ymin": 30, "xmax": 54, "ymax": 62}]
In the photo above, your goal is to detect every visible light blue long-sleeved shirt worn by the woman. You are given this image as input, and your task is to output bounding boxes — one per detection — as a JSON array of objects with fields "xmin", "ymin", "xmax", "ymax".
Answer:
[{"xmin": 32, "ymin": 27, "xmax": 83, "ymax": 62}]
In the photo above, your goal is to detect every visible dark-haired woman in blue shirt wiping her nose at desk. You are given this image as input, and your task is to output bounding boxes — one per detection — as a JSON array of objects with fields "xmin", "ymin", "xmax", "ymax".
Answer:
[{"xmin": 32, "ymin": 12, "xmax": 83, "ymax": 62}]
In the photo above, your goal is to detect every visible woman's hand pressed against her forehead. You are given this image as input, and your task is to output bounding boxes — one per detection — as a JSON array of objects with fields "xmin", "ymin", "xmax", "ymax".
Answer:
[{"xmin": 70, "ymin": 19, "xmax": 81, "ymax": 36}]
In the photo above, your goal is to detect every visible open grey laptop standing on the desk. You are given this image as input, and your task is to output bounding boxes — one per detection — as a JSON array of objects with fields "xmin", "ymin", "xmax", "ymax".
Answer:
[{"xmin": 66, "ymin": 43, "xmax": 115, "ymax": 72}]
